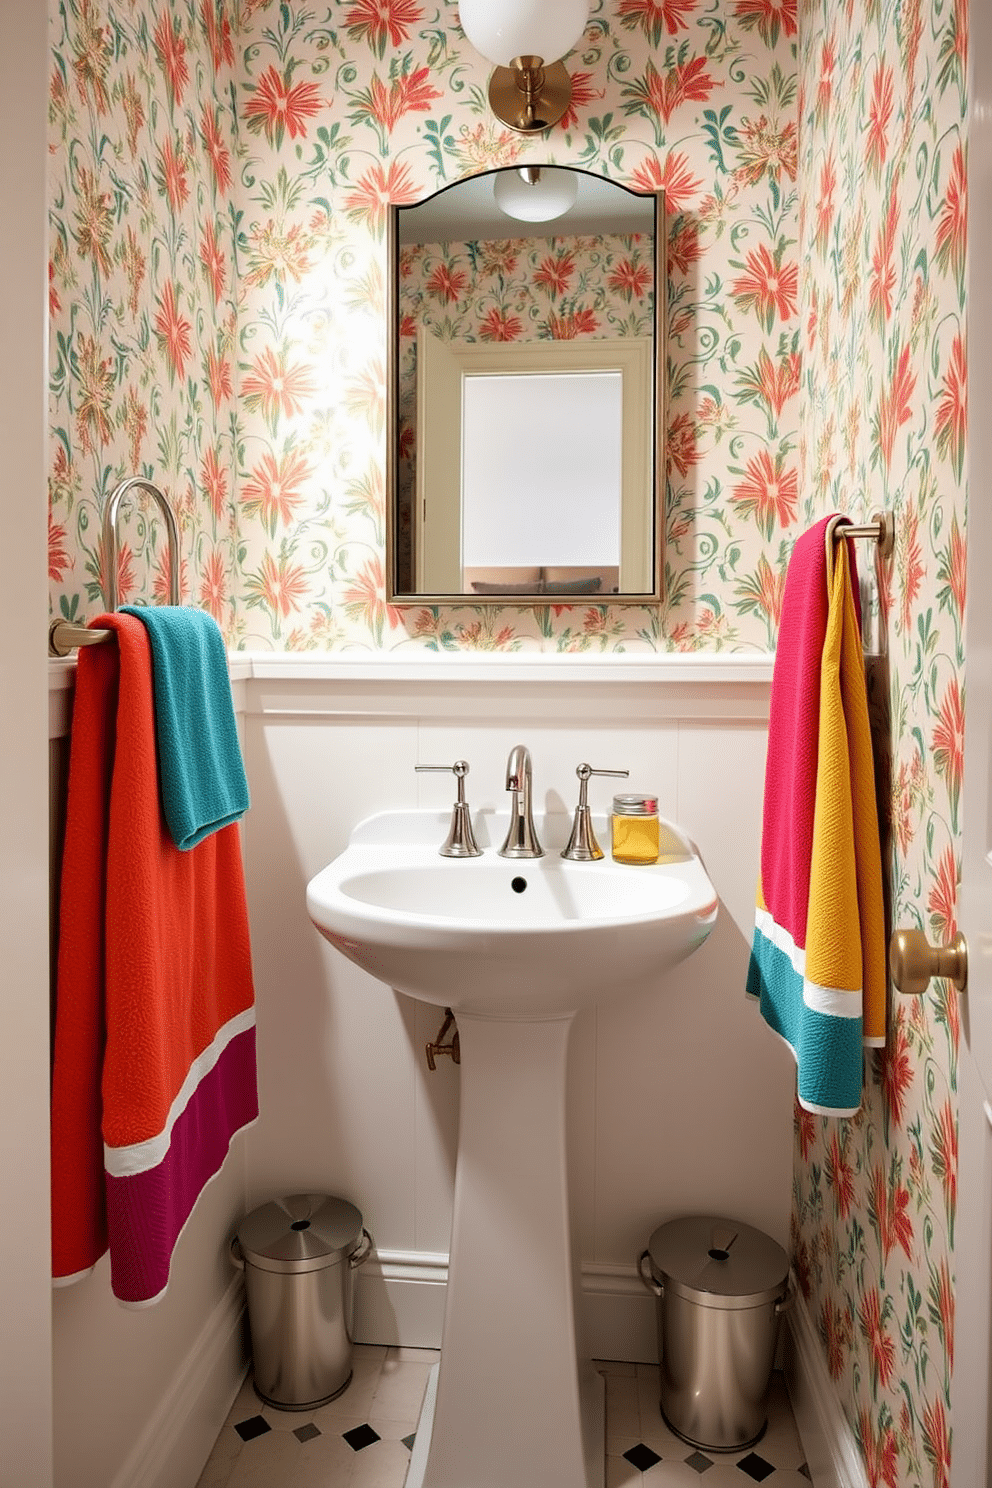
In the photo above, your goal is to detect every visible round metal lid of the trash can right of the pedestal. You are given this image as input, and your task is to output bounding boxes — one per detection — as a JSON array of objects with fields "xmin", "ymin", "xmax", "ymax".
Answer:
[{"xmin": 648, "ymin": 1214, "xmax": 788, "ymax": 1308}]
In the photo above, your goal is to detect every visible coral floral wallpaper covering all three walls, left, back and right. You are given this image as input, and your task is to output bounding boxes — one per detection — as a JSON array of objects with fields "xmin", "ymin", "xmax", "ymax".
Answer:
[{"xmin": 49, "ymin": 0, "xmax": 967, "ymax": 1488}]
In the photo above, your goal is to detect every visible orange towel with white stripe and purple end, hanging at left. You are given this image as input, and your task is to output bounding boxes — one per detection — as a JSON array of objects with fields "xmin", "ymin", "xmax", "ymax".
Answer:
[{"xmin": 52, "ymin": 615, "xmax": 257, "ymax": 1305}]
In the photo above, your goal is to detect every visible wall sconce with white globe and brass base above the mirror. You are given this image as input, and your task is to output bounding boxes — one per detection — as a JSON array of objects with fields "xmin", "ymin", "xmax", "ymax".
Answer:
[{"xmin": 458, "ymin": 0, "xmax": 589, "ymax": 134}]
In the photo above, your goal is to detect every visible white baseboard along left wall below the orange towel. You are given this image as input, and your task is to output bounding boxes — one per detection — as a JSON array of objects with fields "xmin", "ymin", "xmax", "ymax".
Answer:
[{"xmin": 110, "ymin": 1275, "xmax": 248, "ymax": 1488}]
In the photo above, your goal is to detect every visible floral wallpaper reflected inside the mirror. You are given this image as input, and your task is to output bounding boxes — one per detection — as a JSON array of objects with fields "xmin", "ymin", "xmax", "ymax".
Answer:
[{"xmin": 397, "ymin": 232, "xmax": 654, "ymax": 591}]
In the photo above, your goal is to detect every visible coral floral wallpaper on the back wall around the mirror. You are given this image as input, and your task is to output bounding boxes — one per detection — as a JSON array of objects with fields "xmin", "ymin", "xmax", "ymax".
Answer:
[{"xmin": 236, "ymin": 0, "xmax": 799, "ymax": 650}]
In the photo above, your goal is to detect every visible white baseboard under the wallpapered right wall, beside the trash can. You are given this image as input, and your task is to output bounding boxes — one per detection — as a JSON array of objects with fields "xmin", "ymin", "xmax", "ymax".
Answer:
[{"xmin": 784, "ymin": 1292, "xmax": 869, "ymax": 1488}]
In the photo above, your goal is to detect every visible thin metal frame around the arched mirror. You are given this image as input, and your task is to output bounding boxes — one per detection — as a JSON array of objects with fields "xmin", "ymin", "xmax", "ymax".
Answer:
[{"xmin": 385, "ymin": 167, "xmax": 668, "ymax": 609}]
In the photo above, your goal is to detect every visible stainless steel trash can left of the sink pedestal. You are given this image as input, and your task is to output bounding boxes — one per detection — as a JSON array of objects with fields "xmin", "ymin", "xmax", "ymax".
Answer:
[{"xmin": 231, "ymin": 1193, "xmax": 372, "ymax": 1411}]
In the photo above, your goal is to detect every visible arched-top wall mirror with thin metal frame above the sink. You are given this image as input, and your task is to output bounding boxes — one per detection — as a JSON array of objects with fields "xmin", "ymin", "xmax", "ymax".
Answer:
[{"xmin": 387, "ymin": 167, "xmax": 665, "ymax": 604}]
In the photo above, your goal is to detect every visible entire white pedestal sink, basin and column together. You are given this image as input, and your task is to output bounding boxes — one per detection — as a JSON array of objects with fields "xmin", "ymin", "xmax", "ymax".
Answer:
[{"xmin": 306, "ymin": 811, "xmax": 717, "ymax": 1488}]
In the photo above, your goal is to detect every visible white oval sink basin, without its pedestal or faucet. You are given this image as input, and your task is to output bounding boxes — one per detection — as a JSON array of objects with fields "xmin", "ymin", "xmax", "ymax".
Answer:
[{"xmin": 306, "ymin": 811, "xmax": 717, "ymax": 1018}]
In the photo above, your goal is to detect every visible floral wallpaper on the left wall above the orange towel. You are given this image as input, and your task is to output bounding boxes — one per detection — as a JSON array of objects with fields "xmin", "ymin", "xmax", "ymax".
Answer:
[{"xmin": 49, "ymin": 0, "xmax": 238, "ymax": 631}]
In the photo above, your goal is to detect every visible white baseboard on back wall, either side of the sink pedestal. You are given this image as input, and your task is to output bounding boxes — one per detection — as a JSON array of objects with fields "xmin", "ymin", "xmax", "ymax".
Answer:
[{"xmin": 354, "ymin": 1250, "xmax": 657, "ymax": 1363}]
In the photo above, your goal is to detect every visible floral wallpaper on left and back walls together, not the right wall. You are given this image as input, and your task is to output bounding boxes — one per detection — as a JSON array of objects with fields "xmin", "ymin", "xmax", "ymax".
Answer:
[{"xmin": 51, "ymin": 0, "xmax": 799, "ymax": 650}]
